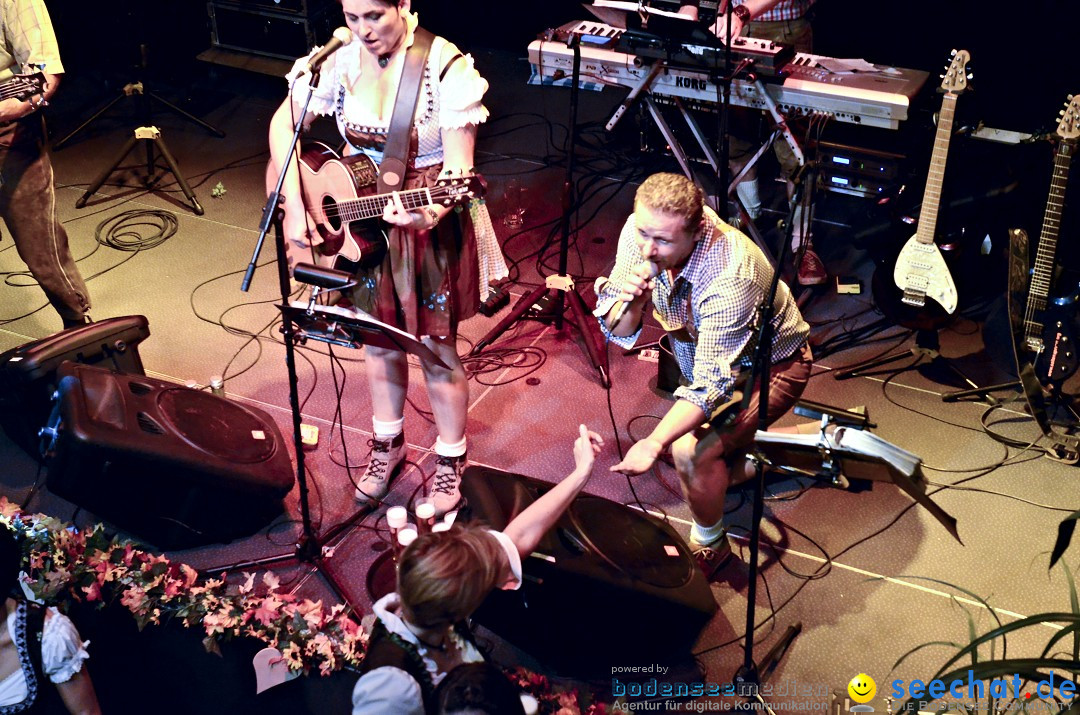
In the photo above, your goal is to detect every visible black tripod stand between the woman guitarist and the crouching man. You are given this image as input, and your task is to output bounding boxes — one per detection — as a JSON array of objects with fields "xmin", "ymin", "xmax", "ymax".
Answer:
[{"xmin": 469, "ymin": 33, "xmax": 611, "ymax": 388}]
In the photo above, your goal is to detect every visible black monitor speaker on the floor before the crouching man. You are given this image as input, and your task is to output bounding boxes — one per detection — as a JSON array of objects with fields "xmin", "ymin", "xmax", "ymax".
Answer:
[{"xmin": 460, "ymin": 467, "xmax": 716, "ymax": 677}]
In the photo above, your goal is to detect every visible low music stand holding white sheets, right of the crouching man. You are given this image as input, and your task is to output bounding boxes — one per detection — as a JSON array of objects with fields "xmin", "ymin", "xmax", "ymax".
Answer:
[{"xmin": 754, "ymin": 415, "xmax": 963, "ymax": 543}]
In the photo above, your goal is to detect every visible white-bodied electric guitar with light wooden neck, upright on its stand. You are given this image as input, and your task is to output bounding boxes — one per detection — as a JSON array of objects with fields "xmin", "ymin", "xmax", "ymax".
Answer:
[{"xmin": 874, "ymin": 50, "xmax": 971, "ymax": 328}]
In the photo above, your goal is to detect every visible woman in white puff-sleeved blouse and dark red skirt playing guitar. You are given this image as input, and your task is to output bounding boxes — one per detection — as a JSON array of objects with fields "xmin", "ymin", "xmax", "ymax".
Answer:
[{"xmin": 270, "ymin": 0, "xmax": 505, "ymax": 515}]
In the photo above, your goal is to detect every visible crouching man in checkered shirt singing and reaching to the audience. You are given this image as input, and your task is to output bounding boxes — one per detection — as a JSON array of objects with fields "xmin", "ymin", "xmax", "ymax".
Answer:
[{"xmin": 595, "ymin": 174, "xmax": 812, "ymax": 579}]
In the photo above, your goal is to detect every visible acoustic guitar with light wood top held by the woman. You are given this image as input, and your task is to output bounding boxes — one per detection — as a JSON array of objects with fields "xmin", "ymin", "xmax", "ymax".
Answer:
[{"xmin": 267, "ymin": 141, "xmax": 487, "ymax": 271}]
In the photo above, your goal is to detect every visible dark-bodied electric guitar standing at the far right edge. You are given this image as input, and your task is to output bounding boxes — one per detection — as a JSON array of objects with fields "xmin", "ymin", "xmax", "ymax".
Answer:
[{"xmin": 1017, "ymin": 95, "xmax": 1080, "ymax": 391}]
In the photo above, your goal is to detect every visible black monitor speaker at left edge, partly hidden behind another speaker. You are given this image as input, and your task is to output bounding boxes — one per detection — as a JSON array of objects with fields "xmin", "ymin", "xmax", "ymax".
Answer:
[{"xmin": 0, "ymin": 315, "xmax": 150, "ymax": 459}]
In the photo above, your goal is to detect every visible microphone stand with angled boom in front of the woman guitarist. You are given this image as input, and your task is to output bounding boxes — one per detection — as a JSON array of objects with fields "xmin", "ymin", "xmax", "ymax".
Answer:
[{"xmin": 219, "ymin": 69, "xmax": 362, "ymax": 611}]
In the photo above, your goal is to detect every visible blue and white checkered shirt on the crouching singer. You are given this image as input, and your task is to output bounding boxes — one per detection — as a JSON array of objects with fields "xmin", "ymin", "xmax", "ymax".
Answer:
[{"xmin": 594, "ymin": 207, "xmax": 810, "ymax": 415}]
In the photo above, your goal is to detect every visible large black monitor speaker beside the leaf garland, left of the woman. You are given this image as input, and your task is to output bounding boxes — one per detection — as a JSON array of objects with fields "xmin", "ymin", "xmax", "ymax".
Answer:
[{"xmin": 46, "ymin": 362, "xmax": 295, "ymax": 549}]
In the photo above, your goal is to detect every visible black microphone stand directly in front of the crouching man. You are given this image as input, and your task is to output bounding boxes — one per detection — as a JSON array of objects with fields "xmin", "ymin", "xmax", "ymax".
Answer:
[{"xmin": 734, "ymin": 159, "xmax": 813, "ymax": 715}]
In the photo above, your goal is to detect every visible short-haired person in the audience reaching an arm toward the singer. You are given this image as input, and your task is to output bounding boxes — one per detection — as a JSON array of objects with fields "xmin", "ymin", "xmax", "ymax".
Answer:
[{"xmin": 352, "ymin": 424, "xmax": 604, "ymax": 715}]
